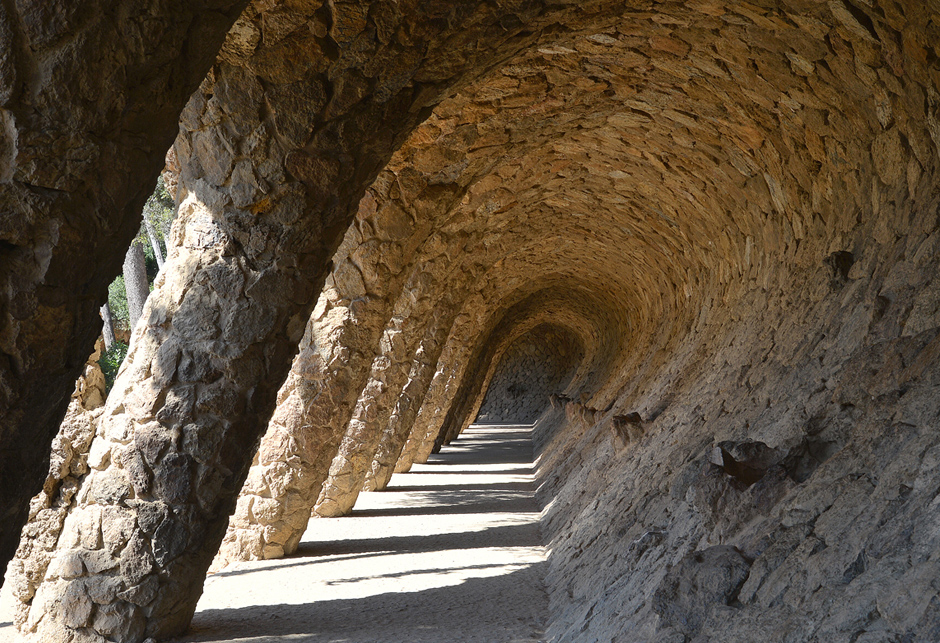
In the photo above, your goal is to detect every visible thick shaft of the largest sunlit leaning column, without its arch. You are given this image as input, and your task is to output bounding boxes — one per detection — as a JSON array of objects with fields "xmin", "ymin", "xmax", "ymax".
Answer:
[{"xmin": 26, "ymin": 42, "xmax": 411, "ymax": 642}]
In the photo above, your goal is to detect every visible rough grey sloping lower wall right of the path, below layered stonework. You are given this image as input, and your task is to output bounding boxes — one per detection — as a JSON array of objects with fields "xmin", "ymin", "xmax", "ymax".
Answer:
[{"xmin": 538, "ymin": 221, "xmax": 940, "ymax": 642}]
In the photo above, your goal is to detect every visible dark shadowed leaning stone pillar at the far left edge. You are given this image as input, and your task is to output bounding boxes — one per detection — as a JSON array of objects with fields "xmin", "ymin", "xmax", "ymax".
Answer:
[{"xmin": 0, "ymin": 0, "xmax": 247, "ymax": 584}]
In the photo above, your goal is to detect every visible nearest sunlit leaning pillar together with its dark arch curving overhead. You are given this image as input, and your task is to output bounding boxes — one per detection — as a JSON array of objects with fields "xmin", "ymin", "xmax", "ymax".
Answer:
[{"xmin": 16, "ymin": 3, "xmax": 640, "ymax": 640}]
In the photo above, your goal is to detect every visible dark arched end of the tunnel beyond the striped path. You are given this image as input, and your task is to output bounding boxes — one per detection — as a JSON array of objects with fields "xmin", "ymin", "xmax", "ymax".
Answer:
[{"xmin": 474, "ymin": 324, "xmax": 584, "ymax": 424}]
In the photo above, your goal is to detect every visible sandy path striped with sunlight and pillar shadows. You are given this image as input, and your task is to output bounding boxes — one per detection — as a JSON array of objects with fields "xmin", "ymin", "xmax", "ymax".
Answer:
[{"xmin": 0, "ymin": 427, "xmax": 547, "ymax": 643}]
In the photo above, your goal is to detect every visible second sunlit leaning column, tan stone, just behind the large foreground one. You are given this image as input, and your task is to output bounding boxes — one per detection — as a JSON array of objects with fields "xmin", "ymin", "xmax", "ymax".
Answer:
[{"xmin": 213, "ymin": 213, "xmax": 426, "ymax": 568}]
